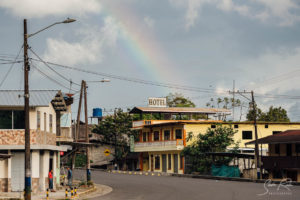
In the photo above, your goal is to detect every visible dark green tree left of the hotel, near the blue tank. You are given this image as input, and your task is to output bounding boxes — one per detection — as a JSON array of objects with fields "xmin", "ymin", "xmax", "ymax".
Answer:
[{"xmin": 92, "ymin": 109, "xmax": 138, "ymax": 166}]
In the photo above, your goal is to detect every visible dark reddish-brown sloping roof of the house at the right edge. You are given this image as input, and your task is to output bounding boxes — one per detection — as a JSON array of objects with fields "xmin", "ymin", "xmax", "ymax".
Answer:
[{"xmin": 246, "ymin": 130, "xmax": 300, "ymax": 145}]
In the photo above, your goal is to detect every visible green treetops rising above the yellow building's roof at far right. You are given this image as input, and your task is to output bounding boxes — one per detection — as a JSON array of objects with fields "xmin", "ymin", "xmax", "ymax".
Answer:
[{"xmin": 247, "ymin": 106, "xmax": 290, "ymax": 122}]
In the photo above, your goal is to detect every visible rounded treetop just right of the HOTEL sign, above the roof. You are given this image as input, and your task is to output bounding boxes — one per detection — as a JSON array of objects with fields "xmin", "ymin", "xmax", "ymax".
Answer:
[{"xmin": 166, "ymin": 93, "xmax": 196, "ymax": 108}]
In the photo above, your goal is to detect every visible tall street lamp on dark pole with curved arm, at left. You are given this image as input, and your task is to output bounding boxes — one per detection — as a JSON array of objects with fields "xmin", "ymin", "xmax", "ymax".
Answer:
[{"xmin": 24, "ymin": 18, "xmax": 75, "ymax": 200}]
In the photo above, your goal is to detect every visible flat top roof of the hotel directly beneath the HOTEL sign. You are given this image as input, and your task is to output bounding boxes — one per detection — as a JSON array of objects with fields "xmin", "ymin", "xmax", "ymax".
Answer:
[{"xmin": 129, "ymin": 107, "xmax": 231, "ymax": 114}]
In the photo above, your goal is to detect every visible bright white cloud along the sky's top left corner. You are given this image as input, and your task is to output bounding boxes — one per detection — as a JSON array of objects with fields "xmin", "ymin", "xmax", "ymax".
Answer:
[{"xmin": 0, "ymin": 0, "xmax": 101, "ymax": 18}]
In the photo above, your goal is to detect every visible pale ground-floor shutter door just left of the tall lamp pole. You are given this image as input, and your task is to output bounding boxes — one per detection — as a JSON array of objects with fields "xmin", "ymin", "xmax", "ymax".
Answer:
[{"xmin": 11, "ymin": 152, "xmax": 25, "ymax": 192}]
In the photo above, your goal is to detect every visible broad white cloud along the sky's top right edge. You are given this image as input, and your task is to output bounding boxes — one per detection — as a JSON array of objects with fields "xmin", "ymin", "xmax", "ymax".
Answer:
[{"xmin": 169, "ymin": 0, "xmax": 300, "ymax": 29}]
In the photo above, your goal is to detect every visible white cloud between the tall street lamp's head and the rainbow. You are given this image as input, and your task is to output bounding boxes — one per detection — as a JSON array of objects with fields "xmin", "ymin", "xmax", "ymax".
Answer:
[{"xmin": 43, "ymin": 17, "xmax": 119, "ymax": 65}]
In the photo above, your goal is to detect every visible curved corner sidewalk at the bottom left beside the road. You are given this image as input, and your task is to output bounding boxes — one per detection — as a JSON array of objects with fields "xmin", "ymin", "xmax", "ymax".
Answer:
[{"xmin": 0, "ymin": 184, "xmax": 112, "ymax": 200}]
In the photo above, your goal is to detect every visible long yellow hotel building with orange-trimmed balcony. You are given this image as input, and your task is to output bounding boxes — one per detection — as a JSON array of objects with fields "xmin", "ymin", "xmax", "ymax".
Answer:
[{"xmin": 131, "ymin": 107, "xmax": 300, "ymax": 174}]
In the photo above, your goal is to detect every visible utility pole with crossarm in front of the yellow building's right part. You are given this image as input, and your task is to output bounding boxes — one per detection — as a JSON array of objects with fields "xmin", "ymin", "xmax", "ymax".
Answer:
[{"xmin": 229, "ymin": 91, "xmax": 262, "ymax": 179}]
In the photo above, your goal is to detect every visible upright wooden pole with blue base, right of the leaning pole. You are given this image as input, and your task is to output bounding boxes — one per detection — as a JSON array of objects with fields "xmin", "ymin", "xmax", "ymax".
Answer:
[{"xmin": 82, "ymin": 81, "xmax": 91, "ymax": 183}]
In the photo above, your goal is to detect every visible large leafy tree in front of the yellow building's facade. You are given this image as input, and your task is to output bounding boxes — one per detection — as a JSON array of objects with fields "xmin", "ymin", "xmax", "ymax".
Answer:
[{"xmin": 182, "ymin": 125, "xmax": 237, "ymax": 174}]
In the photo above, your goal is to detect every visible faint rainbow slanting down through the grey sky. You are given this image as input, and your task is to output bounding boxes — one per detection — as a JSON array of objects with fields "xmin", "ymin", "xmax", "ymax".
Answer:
[{"xmin": 104, "ymin": 4, "xmax": 180, "ymax": 91}]
